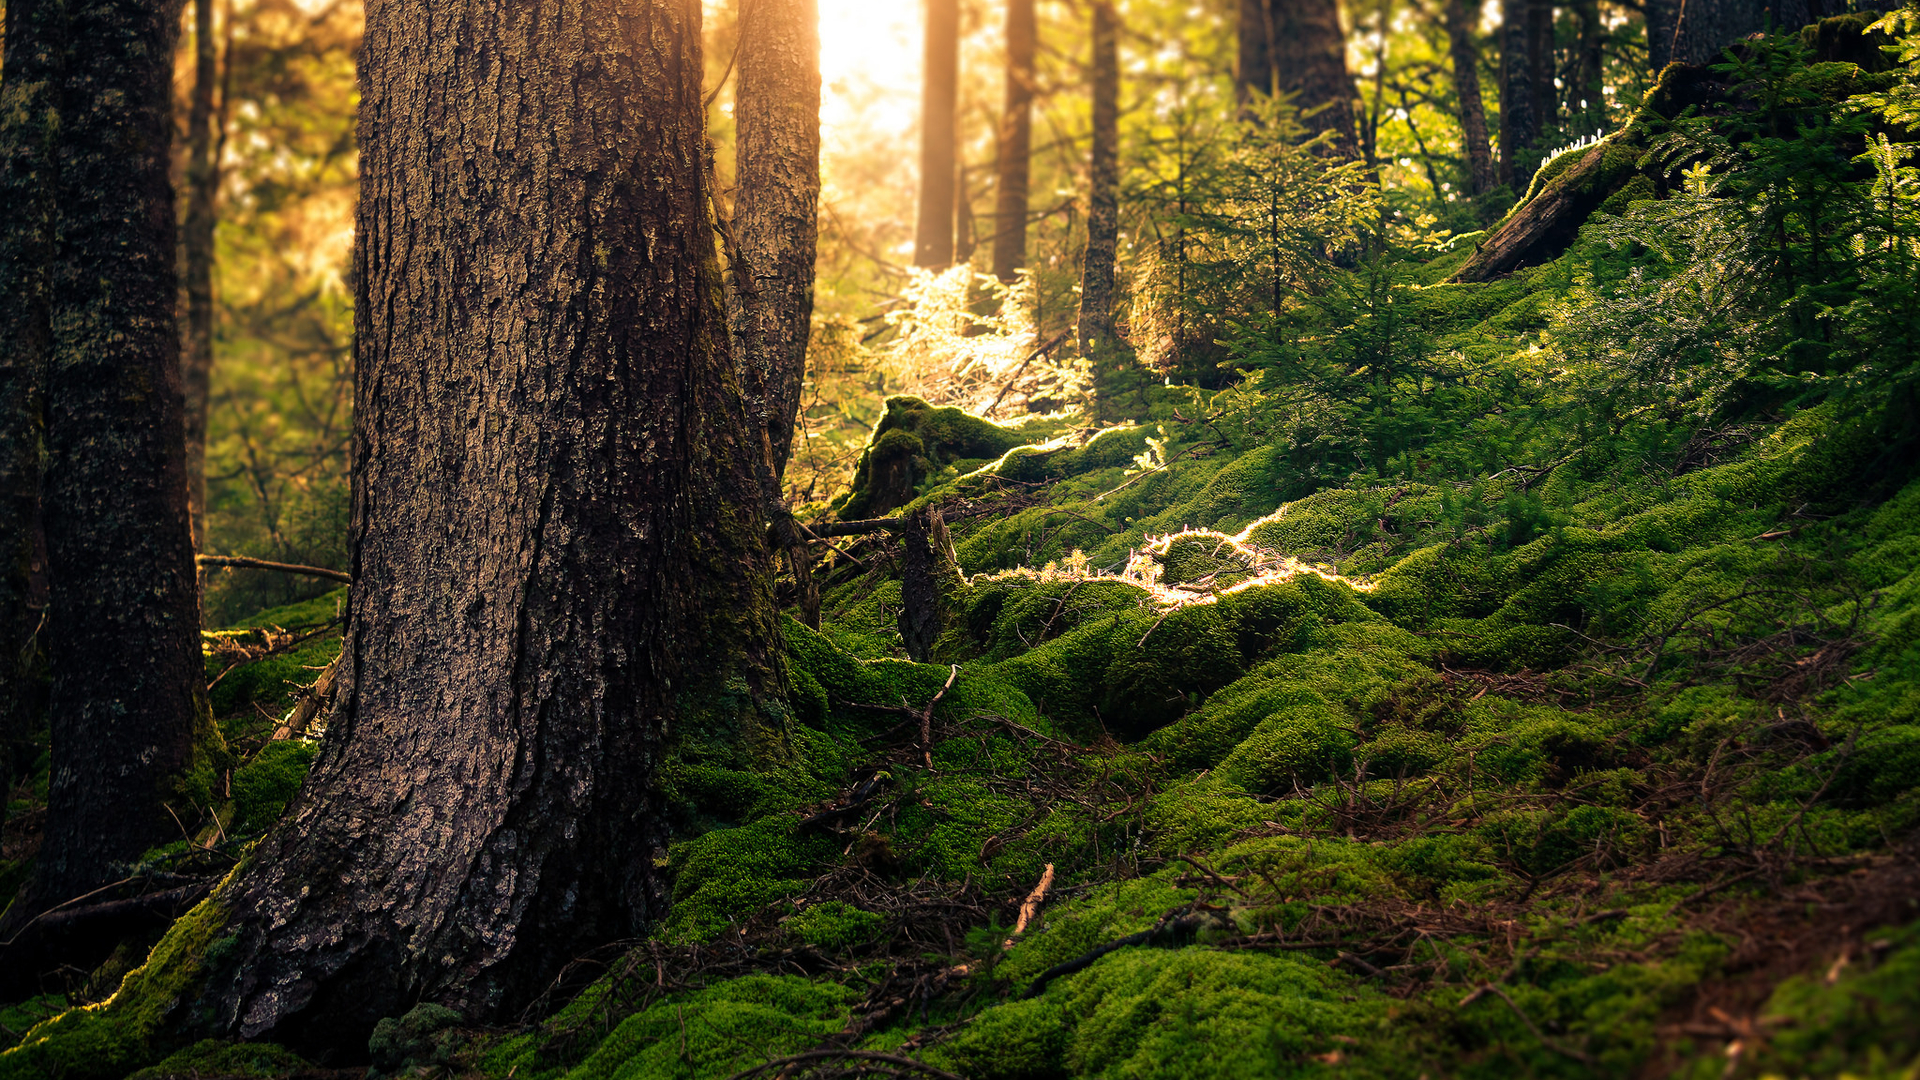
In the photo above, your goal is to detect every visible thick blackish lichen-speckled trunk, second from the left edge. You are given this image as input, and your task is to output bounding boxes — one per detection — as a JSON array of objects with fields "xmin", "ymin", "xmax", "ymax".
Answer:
[{"xmin": 33, "ymin": 0, "xmax": 205, "ymax": 901}]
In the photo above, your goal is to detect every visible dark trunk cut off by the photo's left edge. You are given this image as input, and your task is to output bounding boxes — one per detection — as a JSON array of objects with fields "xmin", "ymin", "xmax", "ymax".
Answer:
[{"xmin": 0, "ymin": 0, "xmax": 60, "ymax": 821}]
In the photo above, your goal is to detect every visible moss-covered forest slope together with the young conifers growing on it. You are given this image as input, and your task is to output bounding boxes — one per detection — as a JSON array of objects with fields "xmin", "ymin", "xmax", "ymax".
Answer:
[{"xmin": 11, "ymin": 10, "xmax": 1920, "ymax": 1080}]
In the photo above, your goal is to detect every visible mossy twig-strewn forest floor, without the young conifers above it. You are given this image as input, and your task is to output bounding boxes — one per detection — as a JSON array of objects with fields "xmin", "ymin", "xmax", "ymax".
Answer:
[{"xmin": 0, "ymin": 244, "xmax": 1920, "ymax": 1080}]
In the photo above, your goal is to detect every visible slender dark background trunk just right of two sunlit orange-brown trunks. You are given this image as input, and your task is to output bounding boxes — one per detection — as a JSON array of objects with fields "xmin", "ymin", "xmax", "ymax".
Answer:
[{"xmin": 1079, "ymin": 0, "xmax": 1119, "ymax": 361}]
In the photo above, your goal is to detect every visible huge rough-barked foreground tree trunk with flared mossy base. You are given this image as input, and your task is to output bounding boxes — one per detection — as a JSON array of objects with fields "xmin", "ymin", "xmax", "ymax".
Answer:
[{"xmin": 196, "ymin": 0, "xmax": 783, "ymax": 1047}]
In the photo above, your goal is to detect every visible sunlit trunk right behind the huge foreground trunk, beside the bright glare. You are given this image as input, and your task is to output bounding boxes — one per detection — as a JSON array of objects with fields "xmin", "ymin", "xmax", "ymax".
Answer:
[{"xmin": 732, "ymin": 0, "xmax": 820, "ymax": 480}]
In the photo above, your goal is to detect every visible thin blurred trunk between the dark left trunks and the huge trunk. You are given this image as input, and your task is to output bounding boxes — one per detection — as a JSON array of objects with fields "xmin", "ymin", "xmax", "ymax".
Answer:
[{"xmin": 180, "ymin": 0, "xmax": 221, "ymax": 552}]
